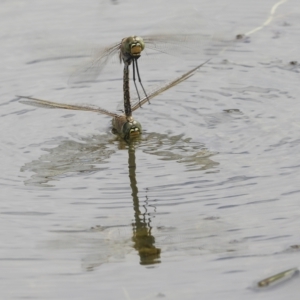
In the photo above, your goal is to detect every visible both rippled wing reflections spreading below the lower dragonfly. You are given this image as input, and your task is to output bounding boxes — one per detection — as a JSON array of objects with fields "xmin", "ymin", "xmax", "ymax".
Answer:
[{"xmin": 21, "ymin": 133, "xmax": 219, "ymax": 187}]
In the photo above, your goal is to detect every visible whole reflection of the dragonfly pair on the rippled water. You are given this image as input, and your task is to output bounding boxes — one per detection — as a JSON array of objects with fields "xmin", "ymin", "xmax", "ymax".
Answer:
[{"xmin": 21, "ymin": 133, "xmax": 218, "ymax": 271}]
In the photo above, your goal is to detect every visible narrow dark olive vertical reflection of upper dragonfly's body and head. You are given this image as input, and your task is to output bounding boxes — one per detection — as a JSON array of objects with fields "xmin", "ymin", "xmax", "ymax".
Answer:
[{"xmin": 128, "ymin": 143, "xmax": 161, "ymax": 265}]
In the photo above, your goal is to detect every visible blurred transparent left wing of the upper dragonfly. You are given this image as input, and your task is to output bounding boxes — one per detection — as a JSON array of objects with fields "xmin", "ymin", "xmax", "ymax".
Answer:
[{"xmin": 69, "ymin": 43, "xmax": 121, "ymax": 83}]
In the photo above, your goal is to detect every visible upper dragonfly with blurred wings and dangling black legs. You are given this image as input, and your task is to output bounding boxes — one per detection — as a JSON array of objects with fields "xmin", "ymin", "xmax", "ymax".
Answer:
[{"xmin": 71, "ymin": 34, "xmax": 229, "ymax": 106}]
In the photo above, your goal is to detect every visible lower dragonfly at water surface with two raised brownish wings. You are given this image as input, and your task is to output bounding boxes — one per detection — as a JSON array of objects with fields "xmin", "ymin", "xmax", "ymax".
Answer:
[{"xmin": 18, "ymin": 61, "xmax": 207, "ymax": 140}]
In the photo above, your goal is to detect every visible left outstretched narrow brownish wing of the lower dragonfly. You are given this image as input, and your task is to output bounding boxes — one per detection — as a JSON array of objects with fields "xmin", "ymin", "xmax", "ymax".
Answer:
[{"xmin": 17, "ymin": 96, "xmax": 118, "ymax": 117}]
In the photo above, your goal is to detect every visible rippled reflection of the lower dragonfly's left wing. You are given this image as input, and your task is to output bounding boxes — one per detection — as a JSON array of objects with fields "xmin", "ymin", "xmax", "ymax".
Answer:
[{"xmin": 21, "ymin": 134, "xmax": 116, "ymax": 187}]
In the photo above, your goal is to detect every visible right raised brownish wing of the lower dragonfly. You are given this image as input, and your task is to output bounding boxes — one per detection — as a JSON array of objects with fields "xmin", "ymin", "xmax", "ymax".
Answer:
[{"xmin": 131, "ymin": 60, "xmax": 209, "ymax": 111}]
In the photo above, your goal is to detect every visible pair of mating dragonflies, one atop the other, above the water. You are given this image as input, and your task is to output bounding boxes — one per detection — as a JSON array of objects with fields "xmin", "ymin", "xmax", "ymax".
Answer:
[{"xmin": 19, "ymin": 36, "xmax": 203, "ymax": 140}]
